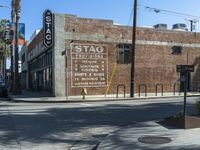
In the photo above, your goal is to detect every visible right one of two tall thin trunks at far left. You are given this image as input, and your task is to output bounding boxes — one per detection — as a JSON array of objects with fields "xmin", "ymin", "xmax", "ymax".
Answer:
[{"xmin": 11, "ymin": 0, "xmax": 20, "ymax": 95}]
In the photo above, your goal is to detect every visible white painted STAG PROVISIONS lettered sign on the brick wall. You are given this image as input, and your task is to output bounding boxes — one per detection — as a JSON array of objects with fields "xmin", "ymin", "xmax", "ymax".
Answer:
[{"xmin": 71, "ymin": 43, "xmax": 108, "ymax": 87}]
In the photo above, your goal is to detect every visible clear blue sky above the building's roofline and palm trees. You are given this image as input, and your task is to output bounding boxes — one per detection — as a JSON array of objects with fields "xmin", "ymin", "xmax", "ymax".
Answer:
[{"xmin": 0, "ymin": 0, "xmax": 200, "ymax": 40}]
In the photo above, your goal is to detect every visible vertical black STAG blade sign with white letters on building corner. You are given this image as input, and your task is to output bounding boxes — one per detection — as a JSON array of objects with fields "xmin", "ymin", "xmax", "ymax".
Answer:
[{"xmin": 43, "ymin": 10, "xmax": 53, "ymax": 47}]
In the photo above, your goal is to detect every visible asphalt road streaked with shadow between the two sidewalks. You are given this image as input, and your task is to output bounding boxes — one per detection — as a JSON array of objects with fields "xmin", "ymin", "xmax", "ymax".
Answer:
[{"xmin": 0, "ymin": 98, "xmax": 199, "ymax": 150}]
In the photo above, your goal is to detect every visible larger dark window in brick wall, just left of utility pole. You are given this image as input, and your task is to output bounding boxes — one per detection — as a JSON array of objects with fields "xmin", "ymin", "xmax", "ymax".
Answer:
[{"xmin": 117, "ymin": 44, "xmax": 131, "ymax": 64}]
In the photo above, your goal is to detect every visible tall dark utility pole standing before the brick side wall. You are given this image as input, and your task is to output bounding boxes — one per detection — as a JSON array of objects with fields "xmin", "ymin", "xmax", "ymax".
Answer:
[{"xmin": 130, "ymin": 0, "xmax": 137, "ymax": 97}]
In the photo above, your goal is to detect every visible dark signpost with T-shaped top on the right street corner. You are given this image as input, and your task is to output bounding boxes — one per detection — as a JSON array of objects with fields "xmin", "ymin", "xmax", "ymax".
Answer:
[{"xmin": 176, "ymin": 65, "xmax": 194, "ymax": 117}]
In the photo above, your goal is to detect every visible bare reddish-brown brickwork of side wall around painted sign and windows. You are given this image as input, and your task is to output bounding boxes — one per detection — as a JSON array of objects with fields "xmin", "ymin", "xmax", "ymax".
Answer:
[{"xmin": 65, "ymin": 17, "xmax": 200, "ymax": 95}]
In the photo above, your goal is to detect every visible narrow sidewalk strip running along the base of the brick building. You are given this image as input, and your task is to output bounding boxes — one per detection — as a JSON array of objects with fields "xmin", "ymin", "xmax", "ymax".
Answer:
[{"xmin": 9, "ymin": 91, "xmax": 200, "ymax": 102}]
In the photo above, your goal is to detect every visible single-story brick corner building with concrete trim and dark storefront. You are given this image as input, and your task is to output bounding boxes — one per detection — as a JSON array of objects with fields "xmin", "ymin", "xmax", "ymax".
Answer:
[{"xmin": 25, "ymin": 14, "xmax": 200, "ymax": 96}]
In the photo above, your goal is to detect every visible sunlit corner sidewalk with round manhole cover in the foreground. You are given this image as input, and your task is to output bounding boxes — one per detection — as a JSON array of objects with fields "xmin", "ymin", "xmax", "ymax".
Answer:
[{"xmin": 97, "ymin": 121, "xmax": 200, "ymax": 150}]
